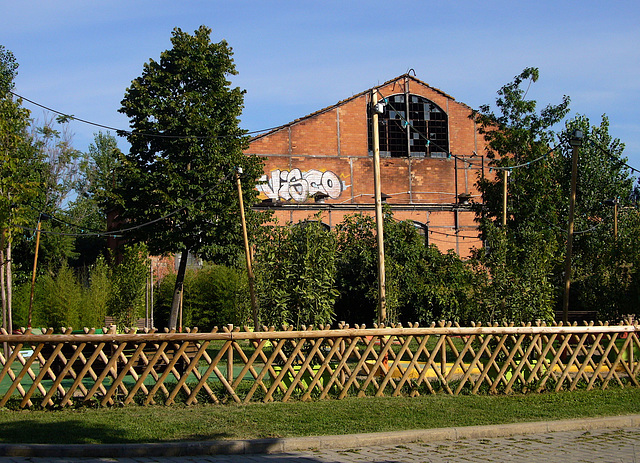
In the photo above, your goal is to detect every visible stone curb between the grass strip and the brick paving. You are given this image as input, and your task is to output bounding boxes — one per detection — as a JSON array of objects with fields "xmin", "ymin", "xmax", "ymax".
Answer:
[{"xmin": 0, "ymin": 415, "xmax": 640, "ymax": 458}]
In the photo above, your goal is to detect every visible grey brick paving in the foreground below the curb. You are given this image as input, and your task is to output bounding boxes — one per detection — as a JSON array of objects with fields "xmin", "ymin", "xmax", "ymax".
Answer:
[{"xmin": 0, "ymin": 427, "xmax": 640, "ymax": 463}]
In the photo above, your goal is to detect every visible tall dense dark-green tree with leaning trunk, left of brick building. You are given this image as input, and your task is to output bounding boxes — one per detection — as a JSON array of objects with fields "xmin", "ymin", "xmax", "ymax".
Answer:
[{"xmin": 118, "ymin": 26, "xmax": 262, "ymax": 328}]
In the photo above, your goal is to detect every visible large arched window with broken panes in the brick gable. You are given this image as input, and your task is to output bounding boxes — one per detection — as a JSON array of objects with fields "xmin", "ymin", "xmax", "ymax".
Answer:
[{"xmin": 367, "ymin": 94, "xmax": 449, "ymax": 158}]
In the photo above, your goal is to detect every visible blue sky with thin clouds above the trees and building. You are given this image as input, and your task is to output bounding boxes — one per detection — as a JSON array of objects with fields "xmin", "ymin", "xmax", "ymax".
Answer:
[{"xmin": 0, "ymin": 0, "xmax": 640, "ymax": 181}]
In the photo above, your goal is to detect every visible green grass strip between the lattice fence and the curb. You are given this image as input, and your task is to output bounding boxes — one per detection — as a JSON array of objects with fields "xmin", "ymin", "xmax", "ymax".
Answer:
[{"xmin": 0, "ymin": 387, "xmax": 640, "ymax": 444}]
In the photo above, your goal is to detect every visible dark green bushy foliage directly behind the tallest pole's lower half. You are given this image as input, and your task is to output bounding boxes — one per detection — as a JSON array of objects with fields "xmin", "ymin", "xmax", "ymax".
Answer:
[{"xmin": 336, "ymin": 213, "xmax": 474, "ymax": 324}]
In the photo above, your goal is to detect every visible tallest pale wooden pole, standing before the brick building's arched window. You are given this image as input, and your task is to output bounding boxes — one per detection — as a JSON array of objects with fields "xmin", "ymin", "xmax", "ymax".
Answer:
[{"xmin": 371, "ymin": 90, "xmax": 387, "ymax": 324}]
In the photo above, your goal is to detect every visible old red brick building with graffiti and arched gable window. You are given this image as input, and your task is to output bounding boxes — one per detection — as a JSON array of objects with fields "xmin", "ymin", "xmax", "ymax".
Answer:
[{"xmin": 246, "ymin": 74, "xmax": 488, "ymax": 257}]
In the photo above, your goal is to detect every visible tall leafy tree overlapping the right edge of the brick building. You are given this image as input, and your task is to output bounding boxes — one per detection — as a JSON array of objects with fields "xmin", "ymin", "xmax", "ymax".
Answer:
[{"xmin": 472, "ymin": 68, "xmax": 569, "ymax": 322}]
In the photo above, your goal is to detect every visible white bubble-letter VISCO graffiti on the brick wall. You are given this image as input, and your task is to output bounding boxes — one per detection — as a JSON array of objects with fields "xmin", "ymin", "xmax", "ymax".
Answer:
[{"xmin": 257, "ymin": 169, "xmax": 345, "ymax": 203}]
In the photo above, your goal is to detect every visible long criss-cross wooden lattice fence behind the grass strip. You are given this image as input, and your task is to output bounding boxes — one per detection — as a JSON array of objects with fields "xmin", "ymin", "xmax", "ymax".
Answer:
[{"xmin": 0, "ymin": 322, "xmax": 640, "ymax": 408}]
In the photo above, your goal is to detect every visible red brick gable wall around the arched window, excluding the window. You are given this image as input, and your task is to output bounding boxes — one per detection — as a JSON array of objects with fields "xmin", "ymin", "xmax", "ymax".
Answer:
[{"xmin": 246, "ymin": 76, "xmax": 488, "ymax": 256}]
